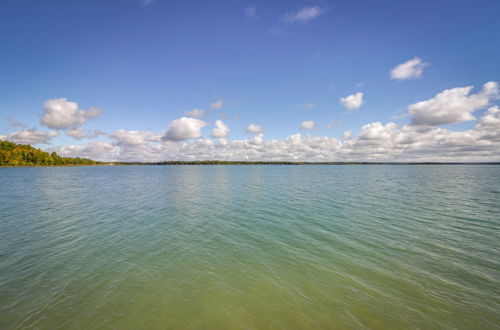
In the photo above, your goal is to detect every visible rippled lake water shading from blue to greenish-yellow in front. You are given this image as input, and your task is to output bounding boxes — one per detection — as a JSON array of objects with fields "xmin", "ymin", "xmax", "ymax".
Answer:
[{"xmin": 0, "ymin": 165, "xmax": 500, "ymax": 329}]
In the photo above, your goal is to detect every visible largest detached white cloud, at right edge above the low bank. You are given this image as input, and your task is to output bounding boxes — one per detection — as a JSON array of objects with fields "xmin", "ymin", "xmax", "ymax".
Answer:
[{"xmin": 408, "ymin": 82, "xmax": 499, "ymax": 126}]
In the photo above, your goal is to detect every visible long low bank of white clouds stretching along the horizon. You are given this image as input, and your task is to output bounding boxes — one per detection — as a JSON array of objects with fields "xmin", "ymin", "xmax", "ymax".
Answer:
[{"xmin": 52, "ymin": 106, "xmax": 500, "ymax": 162}]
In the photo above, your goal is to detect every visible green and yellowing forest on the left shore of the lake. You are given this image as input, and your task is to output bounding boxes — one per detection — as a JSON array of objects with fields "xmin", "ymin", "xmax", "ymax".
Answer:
[{"xmin": 0, "ymin": 140, "xmax": 101, "ymax": 166}]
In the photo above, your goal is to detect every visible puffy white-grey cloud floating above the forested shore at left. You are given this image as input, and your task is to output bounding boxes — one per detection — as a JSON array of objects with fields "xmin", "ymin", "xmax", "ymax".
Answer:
[{"xmin": 40, "ymin": 98, "xmax": 101, "ymax": 129}]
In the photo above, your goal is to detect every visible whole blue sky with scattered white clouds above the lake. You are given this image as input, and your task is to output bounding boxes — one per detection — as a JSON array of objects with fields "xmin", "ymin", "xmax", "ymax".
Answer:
[{"xmin": 0, "ymin": 0, "xmax": 500, "ymax": 162}]
